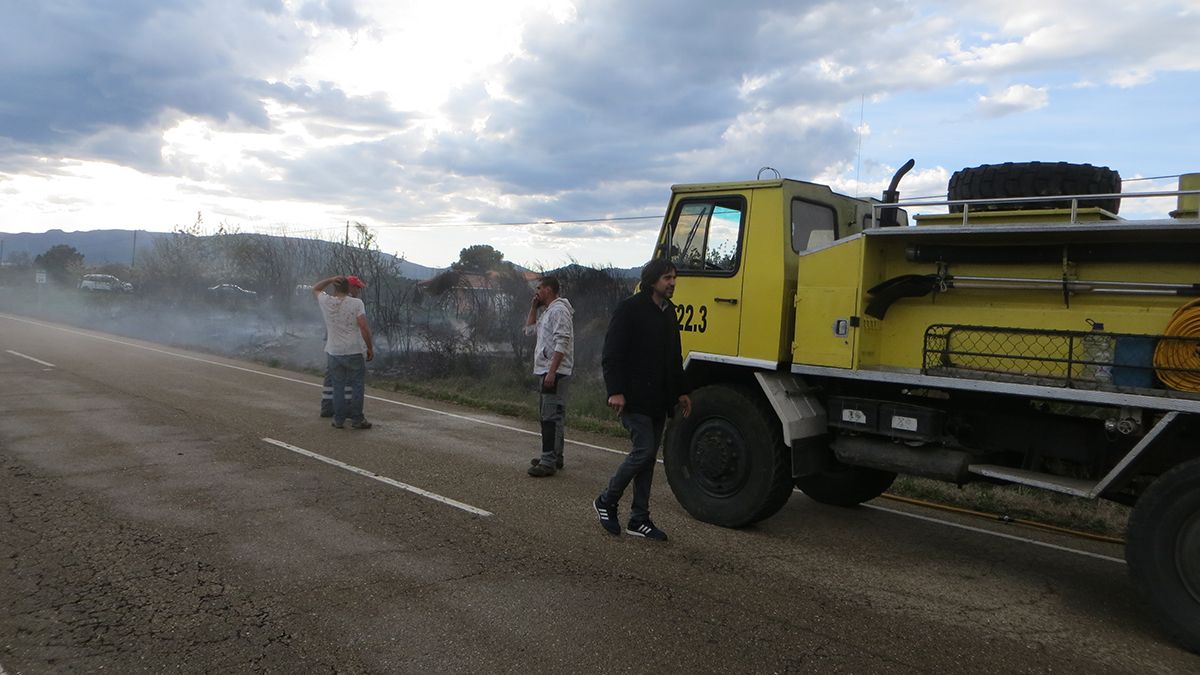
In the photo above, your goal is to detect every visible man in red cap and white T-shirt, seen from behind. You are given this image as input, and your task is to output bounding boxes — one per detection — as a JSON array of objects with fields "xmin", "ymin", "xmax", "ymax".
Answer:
[{"xmin": 312, "ymin": 271, "xmax": 374, "ymax": 429}]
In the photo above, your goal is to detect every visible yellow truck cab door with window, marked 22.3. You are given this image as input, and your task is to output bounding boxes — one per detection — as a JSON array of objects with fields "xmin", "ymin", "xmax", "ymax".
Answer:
[{"xmin": 664, "ymin": 195, "xmax": 749, "ymax": 358}]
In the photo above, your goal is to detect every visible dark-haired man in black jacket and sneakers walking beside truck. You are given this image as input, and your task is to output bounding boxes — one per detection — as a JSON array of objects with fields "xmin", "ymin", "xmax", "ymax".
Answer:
[{"xmin": 593, "ymin": 258, "xmax": 691, "ymax": 542}]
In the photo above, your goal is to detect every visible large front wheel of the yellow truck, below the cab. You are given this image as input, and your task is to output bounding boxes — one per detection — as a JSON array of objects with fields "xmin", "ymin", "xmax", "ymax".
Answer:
[{"xmin": 662, "ymin": 384, "xmax": 792, "ymax": 527}]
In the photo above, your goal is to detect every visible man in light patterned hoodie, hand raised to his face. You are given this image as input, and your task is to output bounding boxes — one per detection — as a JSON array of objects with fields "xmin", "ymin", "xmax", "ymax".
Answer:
[{"xmin": 524, "ymin": 276, "xmax": 575, "ymax": 478}]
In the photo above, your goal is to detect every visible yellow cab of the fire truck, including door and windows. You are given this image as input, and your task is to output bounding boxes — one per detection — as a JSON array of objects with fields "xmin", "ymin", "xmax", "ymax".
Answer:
[{"xmin": 658, "ymin": 179, "xmax": 870, "ymax": 369}]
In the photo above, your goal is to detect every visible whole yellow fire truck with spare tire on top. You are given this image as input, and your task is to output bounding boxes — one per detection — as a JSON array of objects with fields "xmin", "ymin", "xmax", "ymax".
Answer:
[{"xmin": 655, "ymin": 161, "xmax": 1200, "ymax": 652}]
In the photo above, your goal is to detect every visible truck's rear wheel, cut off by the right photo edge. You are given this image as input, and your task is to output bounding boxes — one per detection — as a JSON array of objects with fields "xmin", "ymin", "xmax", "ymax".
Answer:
[{"xmin": 1126, "ymin": 459, "xmax": 1200, "ymax": 653}]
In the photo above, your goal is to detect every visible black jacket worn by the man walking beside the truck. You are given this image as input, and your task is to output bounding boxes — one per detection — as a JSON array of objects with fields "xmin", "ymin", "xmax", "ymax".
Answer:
[{"xmin": 601, "ymin": 291, "xmax": 688, "ymax": 417}]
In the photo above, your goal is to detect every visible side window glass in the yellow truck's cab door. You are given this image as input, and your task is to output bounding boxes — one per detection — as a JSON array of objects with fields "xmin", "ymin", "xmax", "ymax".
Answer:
[{"xmin": 670, "ymin": 197, "xmax": 745, "ymax": 275}]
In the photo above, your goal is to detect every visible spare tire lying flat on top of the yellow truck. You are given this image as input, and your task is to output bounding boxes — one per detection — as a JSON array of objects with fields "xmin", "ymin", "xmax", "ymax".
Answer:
[{"xmin": 947, "ymin": 162, "xmax": 1121, "ymax": 214}]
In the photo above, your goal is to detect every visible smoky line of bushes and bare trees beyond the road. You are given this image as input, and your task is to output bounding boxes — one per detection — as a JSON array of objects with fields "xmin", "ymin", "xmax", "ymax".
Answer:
[{"xmin": 0, "ymin": 219, "xmax": 635, "ymax": 375}]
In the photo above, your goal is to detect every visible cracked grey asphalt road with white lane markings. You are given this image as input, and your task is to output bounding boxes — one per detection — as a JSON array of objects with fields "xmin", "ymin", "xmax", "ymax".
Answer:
[{"xmin": 0, "ymin": 315, "xmax": 1200, "ymax": 675}]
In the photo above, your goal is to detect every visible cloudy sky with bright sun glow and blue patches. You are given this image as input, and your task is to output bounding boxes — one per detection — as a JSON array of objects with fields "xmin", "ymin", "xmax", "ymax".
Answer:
[{"xmin": 0, "ymin": 0, "xmax": 1200, "ymax": 267}]
